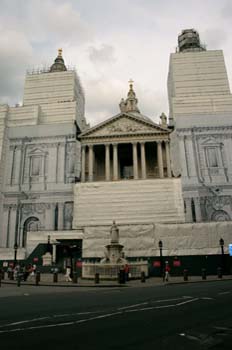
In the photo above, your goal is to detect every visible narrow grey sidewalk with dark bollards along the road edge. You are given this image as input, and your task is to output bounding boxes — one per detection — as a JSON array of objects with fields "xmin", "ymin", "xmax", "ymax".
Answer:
[{"xmin": 1, "ymin": 274, "xmax": 232, "ymax": 288}]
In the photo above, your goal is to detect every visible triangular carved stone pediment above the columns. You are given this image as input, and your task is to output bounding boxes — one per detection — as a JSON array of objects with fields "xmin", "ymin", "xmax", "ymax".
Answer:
[{"xmin": 80, "ymin": 113, "xmax": 170, "ymax": 138}]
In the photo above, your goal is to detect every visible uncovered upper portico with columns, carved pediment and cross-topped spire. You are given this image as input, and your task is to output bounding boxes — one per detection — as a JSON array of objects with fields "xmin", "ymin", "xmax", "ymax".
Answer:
[{"xmin": 80, "ymin": 83, "xmax": 172, "ymax": 182}]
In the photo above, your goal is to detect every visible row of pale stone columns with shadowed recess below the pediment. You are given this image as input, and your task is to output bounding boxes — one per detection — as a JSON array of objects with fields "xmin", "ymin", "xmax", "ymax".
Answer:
[{"xmin": 81, "ymin": 136, "xmax": 171, "ymax": 182}]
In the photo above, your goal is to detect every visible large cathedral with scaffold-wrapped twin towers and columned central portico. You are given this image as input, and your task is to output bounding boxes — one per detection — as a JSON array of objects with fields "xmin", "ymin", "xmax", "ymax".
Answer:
[{"xmin": 0, "ymin": 29, "xmax": 232, "ymax": 265}]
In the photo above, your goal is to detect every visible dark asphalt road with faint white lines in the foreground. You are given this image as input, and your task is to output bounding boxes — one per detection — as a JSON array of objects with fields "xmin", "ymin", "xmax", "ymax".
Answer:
[{"xmin": 0, "ymin": 281, "xmax": 232, "ymax": 350}]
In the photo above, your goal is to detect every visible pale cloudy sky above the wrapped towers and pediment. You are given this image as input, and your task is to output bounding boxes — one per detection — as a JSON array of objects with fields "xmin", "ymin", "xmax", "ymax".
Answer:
[{"xmin": 0, "ymin": 0, "xmax": 232, "ymax": 125}]
